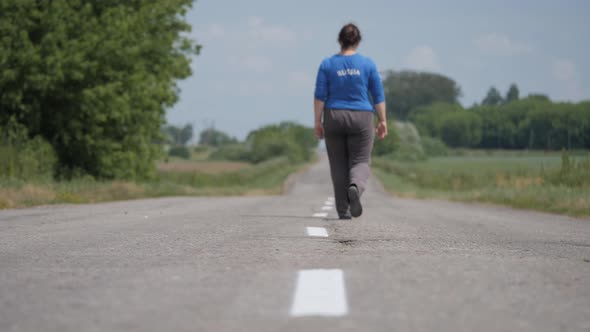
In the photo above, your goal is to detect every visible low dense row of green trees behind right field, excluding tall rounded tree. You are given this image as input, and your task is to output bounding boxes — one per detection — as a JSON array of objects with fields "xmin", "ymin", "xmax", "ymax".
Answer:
[{"xmin": 409, "ymin": 97, "xmax": 590, "ymax": 150}]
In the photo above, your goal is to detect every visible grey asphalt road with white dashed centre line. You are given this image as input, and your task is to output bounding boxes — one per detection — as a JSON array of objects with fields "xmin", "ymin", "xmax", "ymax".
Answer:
[{"xmin": 0, "ymin": 159, "xmax": 590, "ymax": 332}]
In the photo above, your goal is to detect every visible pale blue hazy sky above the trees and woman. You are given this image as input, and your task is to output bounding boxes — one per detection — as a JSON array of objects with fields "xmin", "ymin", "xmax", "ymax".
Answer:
[{"xmin": 167, "ymin": 0, "xmax": 590, "ymax": 139}]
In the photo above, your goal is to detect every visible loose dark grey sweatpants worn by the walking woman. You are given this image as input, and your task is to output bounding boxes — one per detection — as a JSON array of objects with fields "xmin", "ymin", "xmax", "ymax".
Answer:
[{"xmin": 324, "ymin": 110, "xmax": 375, "ymax": 217}]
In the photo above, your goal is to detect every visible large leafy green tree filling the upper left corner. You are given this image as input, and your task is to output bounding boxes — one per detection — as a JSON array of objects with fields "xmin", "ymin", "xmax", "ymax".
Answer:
[{"xmin": 0, "ymin": 0, "xmax": 200, "ymax": 178}]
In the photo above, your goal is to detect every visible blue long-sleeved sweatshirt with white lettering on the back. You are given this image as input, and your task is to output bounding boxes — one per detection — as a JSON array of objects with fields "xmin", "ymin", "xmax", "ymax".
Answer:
[{"xmin": 314, "ymin": 53, "xmax": 385, "ymax": 112}]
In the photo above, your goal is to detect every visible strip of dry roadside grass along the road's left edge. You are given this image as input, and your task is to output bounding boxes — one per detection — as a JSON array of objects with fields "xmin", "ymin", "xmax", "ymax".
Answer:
[{"xmin": 0, "ymin": 158, "xmax": 306, "ymax": 209}]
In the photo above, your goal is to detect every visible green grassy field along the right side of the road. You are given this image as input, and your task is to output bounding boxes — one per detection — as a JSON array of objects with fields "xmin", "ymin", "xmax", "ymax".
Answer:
[{"xmin": 373, "ymin": 151, "xmax": 590, "ymax": 216}]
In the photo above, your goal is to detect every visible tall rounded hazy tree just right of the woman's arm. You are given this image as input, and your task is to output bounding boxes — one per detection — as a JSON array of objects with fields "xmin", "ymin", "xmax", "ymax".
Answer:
[{"xmin": 383, "ymin": 71, "xmax": 461, "ymax": 121}]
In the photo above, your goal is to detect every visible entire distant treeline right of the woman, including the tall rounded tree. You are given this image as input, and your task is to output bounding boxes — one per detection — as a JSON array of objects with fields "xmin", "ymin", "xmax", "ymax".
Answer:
[{"xmin": 384, "ymin": 71, "xmax": 590, "ymax": 150}]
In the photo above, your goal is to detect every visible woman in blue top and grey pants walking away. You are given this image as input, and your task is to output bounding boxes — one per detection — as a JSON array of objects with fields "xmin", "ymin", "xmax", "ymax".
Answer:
[{"xmin": 314, "ymin": 24, "xmax": 387, "ymax": 219}]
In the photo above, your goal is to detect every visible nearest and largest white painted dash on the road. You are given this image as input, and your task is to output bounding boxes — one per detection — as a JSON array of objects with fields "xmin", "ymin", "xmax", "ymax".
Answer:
[{"xmin": 291, "ymin": 270, "xmax": 348, "ymax": 317}]
